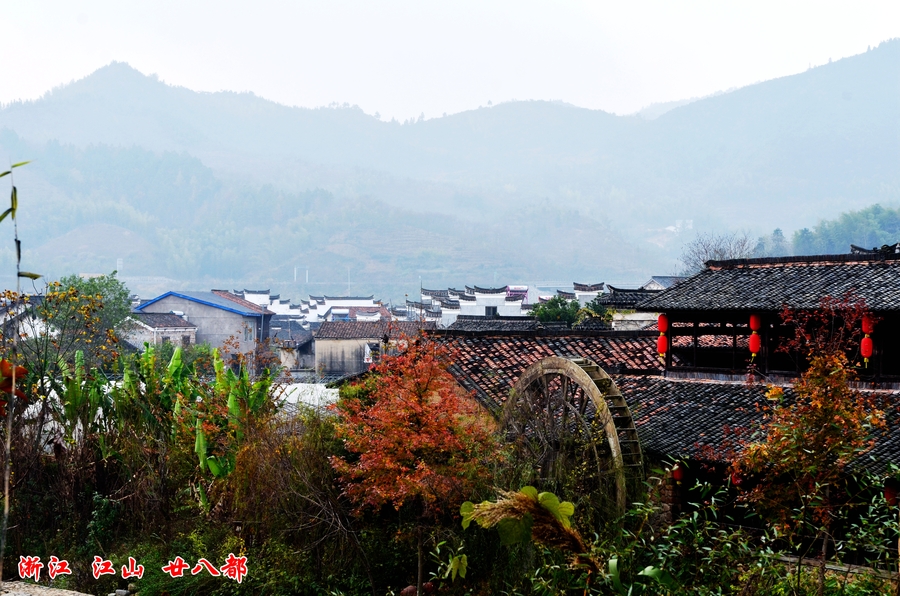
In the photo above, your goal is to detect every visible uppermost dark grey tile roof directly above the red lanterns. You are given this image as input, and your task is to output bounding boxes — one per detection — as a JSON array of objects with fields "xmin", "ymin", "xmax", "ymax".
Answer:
[{"xmin": 638, "ymin": 254, "xmax": 900, "ymax": 312}]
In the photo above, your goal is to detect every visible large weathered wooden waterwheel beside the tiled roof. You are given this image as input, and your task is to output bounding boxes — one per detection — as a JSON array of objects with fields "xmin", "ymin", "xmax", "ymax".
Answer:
[{"xmin": 502, "ymin": 356, "xmax": 643, "ymax": 512}]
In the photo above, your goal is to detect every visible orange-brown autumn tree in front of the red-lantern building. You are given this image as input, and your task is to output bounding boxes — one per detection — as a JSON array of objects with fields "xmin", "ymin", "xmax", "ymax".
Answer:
[{"xmin": 732, "ymin": 298, "xmax": 885, "ymax": 532}]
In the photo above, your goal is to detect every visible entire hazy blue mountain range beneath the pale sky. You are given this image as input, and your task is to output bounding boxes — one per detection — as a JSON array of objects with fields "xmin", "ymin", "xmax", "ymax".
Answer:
[{"xmin": 0, "ymin": 40, "xmax": 900, "ymax": 298}]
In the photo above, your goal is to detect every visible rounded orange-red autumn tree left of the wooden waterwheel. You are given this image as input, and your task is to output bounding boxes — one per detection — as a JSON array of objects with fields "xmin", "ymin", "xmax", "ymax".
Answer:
[{"xmin": 332, "ymin": 337, "xmax": 499, "ymax": 517}]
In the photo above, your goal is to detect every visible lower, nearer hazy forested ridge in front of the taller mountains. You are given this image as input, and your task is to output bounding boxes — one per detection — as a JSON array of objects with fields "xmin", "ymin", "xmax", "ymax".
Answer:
[{"xmin": 0, "ymin": 130, "xmax": 647, "ymax": 298}]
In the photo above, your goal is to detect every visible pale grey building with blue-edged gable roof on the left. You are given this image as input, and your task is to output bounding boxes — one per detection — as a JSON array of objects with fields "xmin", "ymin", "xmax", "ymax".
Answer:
[{"xmin": 134, "ymin": 290, "xmax": 274, "ymax": 352}]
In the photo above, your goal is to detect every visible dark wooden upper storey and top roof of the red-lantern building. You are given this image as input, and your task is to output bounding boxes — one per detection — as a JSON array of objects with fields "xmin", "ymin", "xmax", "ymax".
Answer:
[{"xmin": 637, "ymin": 251, "xmax": 900, "ymax": 385}]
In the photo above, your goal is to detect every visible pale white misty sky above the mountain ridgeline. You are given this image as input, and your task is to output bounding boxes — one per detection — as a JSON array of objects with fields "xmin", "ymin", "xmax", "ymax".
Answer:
[{"xmin": 0, "ymin": 0, "xmax": 900, "ymax": 120}]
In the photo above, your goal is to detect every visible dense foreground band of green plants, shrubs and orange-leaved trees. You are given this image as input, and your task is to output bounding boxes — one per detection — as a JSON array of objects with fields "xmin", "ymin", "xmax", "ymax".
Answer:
[{"xmin": 0, "ymin": 280, "xmax": 900, "ymax": 596}]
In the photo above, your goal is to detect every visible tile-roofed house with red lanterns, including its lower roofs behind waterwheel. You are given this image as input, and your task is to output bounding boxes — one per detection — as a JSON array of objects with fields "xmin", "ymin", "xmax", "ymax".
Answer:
[{"xmin": 429, "ymin": 246, "xmax": 900, "ymax": 509}]
